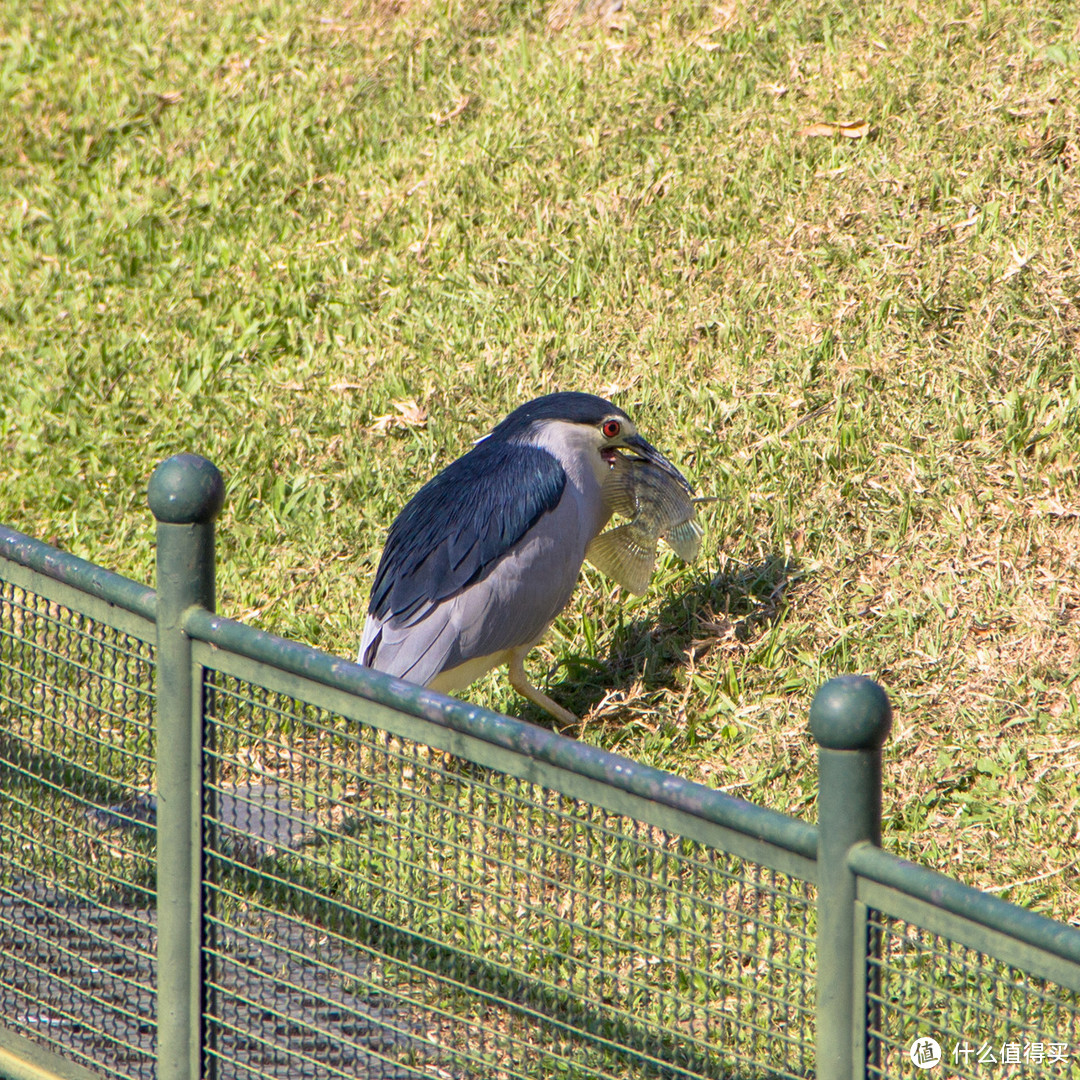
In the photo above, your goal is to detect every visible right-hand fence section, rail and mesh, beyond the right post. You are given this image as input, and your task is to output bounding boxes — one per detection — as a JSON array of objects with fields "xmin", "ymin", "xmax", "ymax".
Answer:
[{"xmin": 848, "ymin": 845, "xmax": 1080, "ymax": 1080}]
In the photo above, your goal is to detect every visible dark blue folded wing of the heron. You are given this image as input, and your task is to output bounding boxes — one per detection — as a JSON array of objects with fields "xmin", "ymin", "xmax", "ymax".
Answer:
[{"xmin": 367, "ymin": 440, "xmax": 566, "ymax": 625}]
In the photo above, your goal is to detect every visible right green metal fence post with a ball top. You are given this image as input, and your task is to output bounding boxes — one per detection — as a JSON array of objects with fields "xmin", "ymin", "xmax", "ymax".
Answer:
[{"xmin": 810, "ymin": 675, "xmax": 892, "ymax": 1080}]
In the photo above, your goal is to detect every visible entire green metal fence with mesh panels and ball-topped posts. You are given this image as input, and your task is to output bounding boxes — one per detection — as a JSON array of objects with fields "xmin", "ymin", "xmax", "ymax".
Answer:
[{"xmin": 0, "ymin": 456, "xmax": 1080, "ymax": 1080}]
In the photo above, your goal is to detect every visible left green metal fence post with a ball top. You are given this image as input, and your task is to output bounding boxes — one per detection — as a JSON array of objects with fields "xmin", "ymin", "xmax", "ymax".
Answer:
[{"xmin": 147, "ymin": 454, "xmax": 225, "ymax": 1080}]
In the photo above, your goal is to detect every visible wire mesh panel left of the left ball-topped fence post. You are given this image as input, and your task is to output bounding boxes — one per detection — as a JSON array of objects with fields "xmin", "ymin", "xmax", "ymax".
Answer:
[{"xmin": 0, "ymin": 580, "xmax": 156, "ymax": 1077}]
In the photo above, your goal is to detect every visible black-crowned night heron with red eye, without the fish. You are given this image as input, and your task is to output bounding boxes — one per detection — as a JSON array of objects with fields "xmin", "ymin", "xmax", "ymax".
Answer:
[{"xmin": 360, "ymin": 393, "xmax": 700, "ymax": 724}]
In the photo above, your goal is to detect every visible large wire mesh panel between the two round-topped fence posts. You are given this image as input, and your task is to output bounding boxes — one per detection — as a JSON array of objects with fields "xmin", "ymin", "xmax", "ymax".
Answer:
[{"xmin": 205, "ymin": 672, "xmax": 813, "ymax": 1080}]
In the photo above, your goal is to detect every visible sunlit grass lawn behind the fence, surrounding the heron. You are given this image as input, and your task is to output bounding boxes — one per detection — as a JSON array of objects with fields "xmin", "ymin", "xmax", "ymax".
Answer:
[{"xmin": 0, "ymin": 0, "xmax": 1080, "ymax": 919}]
